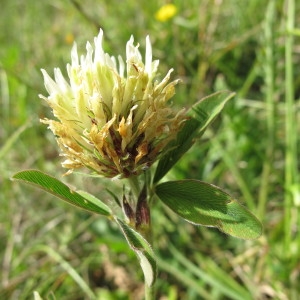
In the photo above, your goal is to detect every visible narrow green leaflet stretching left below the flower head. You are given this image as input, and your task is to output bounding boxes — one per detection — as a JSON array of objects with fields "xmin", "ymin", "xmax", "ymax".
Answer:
[{"xmin": 12, "ymin": 170, "xmax": 111, "ymax": 216}]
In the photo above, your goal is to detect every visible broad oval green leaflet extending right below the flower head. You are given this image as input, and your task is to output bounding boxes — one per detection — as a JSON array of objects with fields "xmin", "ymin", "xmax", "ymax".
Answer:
[{"xmin": 156, "ymin": 179, "xmax": 262, "ymax": 239}]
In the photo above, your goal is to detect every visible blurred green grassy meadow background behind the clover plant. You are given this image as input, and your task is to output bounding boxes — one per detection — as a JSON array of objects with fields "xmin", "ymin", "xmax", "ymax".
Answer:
[{"xmin": 0, "ymin": 0, "xmax": 300, "ymax": 300}]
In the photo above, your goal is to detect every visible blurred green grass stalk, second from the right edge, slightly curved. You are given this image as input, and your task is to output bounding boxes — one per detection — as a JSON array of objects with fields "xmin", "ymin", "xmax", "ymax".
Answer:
[{"xmin": 258, "ymin": 1, "xmax": 275, "ymax": 218}]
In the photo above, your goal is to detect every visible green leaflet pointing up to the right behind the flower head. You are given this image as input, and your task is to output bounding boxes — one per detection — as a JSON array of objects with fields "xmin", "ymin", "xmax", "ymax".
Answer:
[{"xmin": 153, "ymin": 91, "xmax": 235, "ymax": 183}]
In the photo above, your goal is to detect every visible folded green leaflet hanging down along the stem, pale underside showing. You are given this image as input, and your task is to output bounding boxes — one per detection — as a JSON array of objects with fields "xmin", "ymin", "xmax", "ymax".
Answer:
[{"xmin": 115, "ymin": 218, "xmax": 157, "ymax": 287}]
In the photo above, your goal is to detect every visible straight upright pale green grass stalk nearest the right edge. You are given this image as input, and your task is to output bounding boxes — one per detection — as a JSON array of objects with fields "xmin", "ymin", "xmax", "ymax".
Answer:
[{"xmin": 284, "ymin": 0, "xmax": 297, "ymax": 257}]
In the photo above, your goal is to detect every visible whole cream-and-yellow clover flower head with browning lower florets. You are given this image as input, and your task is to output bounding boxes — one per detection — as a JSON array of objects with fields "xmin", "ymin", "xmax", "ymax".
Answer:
[{"xmin": 40, "ymin": 30, "xmax": 185, "ymax": 178}]
